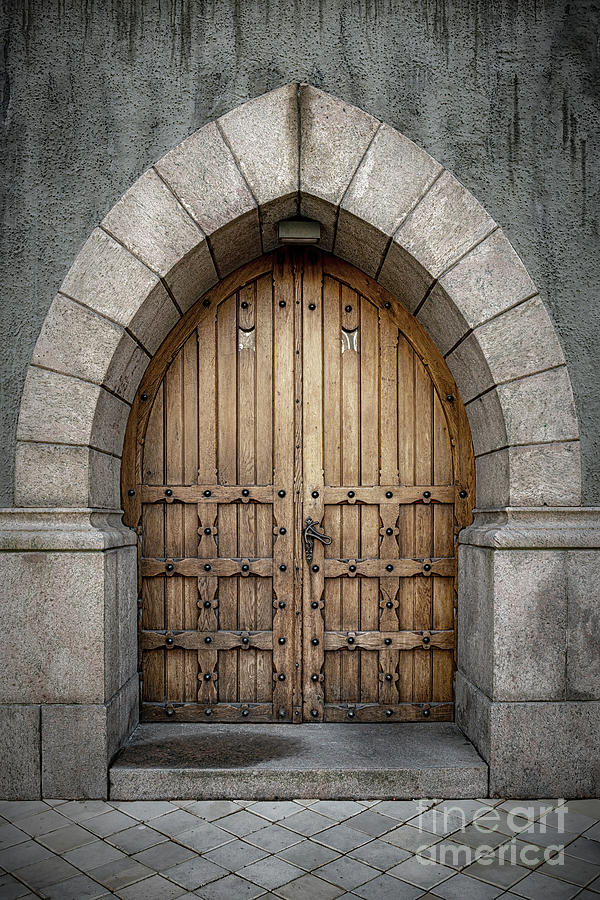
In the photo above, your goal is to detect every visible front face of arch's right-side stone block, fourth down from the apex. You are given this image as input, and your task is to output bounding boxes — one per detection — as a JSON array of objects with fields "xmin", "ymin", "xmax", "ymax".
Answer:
[{"xmin": 439, "ymin": 229, "xmax": 536, "ymax": 328}]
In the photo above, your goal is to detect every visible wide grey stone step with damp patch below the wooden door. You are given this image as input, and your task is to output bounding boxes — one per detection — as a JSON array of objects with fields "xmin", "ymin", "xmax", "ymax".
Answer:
[{"xmin": 109, "ymin": 722, "xmax": 488, "ymax": 800}]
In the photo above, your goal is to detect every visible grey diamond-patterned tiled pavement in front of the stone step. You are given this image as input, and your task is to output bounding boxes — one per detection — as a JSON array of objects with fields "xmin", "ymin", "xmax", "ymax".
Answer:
[{"xmin": 0, "ymin": 800, "xmax": 600, "ymax": 900}]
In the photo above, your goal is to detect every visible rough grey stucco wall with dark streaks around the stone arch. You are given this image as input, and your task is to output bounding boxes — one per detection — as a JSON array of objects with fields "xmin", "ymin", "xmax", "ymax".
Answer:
[{"xmin": 0, "ymin": 0, "xmax": 600, "ymax": 506}]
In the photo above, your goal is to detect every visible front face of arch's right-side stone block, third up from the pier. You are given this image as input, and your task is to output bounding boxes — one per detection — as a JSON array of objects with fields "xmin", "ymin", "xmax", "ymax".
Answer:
[{"xmin": 473, "ymin": 297, "xmax": 565, "ymax": 384}]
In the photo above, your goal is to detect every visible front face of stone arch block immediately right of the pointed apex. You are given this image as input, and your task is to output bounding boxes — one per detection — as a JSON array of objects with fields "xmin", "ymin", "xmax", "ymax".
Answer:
[{"xmin": 300, "ymin": 84, "xmax": 380, "ymax": 206}]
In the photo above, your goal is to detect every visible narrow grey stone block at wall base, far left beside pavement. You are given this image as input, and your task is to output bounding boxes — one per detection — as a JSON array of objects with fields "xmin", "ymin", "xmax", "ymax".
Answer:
[{"xmin": 0, "ymin": 705, "xmax": 41, "ymax": 800}]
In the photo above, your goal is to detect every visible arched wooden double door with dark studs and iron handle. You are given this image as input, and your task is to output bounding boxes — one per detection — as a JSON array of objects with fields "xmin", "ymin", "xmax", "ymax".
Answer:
[{"xmin": 123, "ymin": 248, "xmax": 474, "ymax": 722}]
